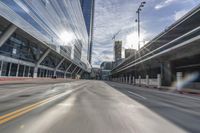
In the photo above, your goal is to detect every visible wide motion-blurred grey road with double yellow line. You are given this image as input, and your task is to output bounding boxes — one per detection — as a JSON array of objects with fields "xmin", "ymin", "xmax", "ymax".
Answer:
[{"xmin": 0, "ymin": 80, "xmax": 200, "ymax": 133}]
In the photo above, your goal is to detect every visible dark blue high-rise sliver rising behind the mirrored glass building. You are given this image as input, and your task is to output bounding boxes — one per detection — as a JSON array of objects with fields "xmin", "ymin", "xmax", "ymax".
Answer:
[{"xmin": 80, "ymin": 0, "xmax": 95, "ymax": 63}]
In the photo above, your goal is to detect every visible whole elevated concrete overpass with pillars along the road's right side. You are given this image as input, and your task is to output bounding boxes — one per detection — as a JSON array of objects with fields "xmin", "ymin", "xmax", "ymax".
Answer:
[{"xmin": 111, "ymin": 6, "xmax": 200, "ymax": 88}]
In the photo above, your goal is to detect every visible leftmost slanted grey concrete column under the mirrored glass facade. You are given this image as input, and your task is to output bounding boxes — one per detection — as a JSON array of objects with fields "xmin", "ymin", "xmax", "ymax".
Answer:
[{"xmin": 0, "ymin": 24, "xmax": 17, "ymax": 47}]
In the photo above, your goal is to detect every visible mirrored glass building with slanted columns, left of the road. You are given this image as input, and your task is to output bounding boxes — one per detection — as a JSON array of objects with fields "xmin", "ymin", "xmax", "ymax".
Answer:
[{"xmin": 0, "ymin": 0, "xmax": 90, "ymax": 77}]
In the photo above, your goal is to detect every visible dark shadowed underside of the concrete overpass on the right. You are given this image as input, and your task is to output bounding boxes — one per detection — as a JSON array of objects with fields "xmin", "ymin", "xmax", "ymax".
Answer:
[{"xmin": 111, "ymin": 39, "xmax": 200, "ymax": 88}]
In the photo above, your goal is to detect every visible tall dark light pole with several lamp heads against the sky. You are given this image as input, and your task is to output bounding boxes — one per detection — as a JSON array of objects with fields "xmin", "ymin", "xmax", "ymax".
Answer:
[{"xmin": 135, "ymin": 1, "xmax": 146, "ymax": 50}]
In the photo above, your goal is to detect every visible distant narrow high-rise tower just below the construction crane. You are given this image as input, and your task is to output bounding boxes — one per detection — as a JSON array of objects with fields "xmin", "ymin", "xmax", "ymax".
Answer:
[{"xmin": 114, "ymin": 41, "xmax": 122, "ymax": 62}]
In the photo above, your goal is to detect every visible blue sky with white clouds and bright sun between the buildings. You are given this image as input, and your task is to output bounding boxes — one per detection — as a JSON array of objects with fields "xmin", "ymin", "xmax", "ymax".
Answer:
[{"xmin": 92, "ymin": 0, "xmax": 200, "ymax": 67}]
